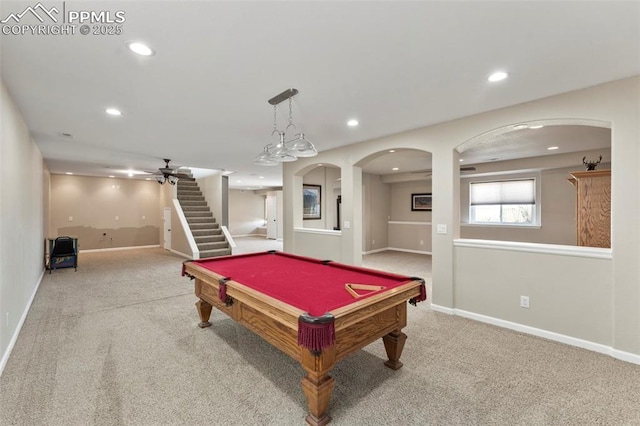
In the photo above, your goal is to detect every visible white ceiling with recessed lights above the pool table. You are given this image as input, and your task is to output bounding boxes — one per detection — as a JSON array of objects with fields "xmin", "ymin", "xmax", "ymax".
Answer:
[{"xmin": 0, "ymin": 0, "xmax": 640, "ymax": 188}]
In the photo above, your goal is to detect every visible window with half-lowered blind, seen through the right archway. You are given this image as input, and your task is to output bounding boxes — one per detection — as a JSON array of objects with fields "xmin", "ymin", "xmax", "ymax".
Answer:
[{"xmin": 469, "ymin": 178, "xmax": 537, "ymax": 225}]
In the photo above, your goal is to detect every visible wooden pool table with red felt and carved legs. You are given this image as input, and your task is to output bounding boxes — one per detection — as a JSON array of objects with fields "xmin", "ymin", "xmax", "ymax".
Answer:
[{"xmin": 182, "ymin": 251, "xmax": 426, "ymax": 425}]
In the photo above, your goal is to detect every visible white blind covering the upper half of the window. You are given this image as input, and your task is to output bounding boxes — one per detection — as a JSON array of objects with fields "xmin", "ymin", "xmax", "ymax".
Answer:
[{"xmin": 469, "ymin": 179, "xmax": 536, "ymax": 206}]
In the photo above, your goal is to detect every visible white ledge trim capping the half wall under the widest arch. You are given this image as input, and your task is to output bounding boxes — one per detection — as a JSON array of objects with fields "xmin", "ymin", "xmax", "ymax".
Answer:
[{"xmin": 453, "ymin": 239, "xmax": 613, "ymax": 260}]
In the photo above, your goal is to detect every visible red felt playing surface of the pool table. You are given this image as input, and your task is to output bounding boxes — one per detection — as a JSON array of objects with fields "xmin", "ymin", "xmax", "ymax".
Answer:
[{"xmin": 186, "ymin": 251, "xmax": 412, "ymax": 315}]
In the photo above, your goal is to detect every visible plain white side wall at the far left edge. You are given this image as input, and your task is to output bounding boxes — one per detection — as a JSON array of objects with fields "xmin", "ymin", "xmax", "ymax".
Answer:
[{"xmin": 0, "ymin": 82, "xmax": 48, "ymax": 374}]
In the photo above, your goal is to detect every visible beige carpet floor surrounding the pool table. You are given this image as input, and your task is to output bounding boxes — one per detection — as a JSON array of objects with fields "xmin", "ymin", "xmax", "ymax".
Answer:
[{"xmin": 0, "ymin": 238, "xmax": 640, "ymax": 425}]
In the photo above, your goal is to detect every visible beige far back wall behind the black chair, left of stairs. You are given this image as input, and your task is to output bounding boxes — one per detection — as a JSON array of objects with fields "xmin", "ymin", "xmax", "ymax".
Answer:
[{"xmin": 51, "ymin": 175, "xmax": 165, "ymax": 250}]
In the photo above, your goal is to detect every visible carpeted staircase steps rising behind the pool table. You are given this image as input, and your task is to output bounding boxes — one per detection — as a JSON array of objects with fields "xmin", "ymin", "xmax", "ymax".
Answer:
[{"xmin": 177, "ymin": 175, "xmax": 231, "ymax": 259}]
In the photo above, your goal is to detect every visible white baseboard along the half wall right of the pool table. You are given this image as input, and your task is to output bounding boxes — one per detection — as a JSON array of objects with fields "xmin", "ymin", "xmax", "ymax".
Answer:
[{"xmin": 431, "ymin": 304, "xmax": 640, "ymax": 365}]
